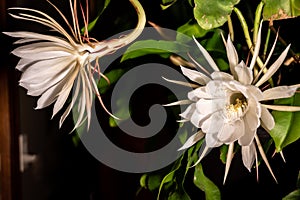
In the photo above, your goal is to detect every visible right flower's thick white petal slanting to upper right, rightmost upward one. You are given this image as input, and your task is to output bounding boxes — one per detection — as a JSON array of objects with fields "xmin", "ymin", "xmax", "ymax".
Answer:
[{"xmin": 255, "ymin": 45, "xmax": 291, "ymax": 87}]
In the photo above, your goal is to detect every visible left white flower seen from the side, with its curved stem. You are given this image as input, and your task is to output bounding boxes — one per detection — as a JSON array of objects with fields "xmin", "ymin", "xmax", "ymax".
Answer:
[{"xmin": 5, "ymin": 0, "xmax": 146, "ymax": 129}]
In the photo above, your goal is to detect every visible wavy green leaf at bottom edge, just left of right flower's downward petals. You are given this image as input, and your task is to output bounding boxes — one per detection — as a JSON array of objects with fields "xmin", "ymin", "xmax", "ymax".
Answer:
[{"xmin": 194, "ymin": 163, "xmax": 221, "ymax": 200}]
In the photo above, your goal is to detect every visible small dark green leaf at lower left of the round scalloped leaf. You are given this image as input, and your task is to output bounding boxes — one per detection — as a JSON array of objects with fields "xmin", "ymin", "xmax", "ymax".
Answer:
[{"xmin": 176, "ymin": 19, "xmax": 209, "ymax": 42}]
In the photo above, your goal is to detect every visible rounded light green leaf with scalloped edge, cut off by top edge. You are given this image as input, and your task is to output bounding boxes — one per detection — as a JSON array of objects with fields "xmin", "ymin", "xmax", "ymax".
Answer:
[{"xmin": 194, "ymin": 0, "xmax": 239, "ymax": 30}]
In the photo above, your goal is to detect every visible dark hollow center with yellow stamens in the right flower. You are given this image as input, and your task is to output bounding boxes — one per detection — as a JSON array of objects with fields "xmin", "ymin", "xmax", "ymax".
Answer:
[{"xmin": 225, "ymin": 93, "xmax": 248, "ymax": 122}]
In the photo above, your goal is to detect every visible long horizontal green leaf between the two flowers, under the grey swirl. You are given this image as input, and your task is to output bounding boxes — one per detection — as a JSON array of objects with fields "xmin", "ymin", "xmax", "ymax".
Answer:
[{"xmin": 121, "ymin": 40, "xmax": 188, "ymax": 62}]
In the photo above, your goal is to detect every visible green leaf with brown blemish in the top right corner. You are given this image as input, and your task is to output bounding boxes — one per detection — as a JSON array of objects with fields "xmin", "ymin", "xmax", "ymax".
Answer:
[{"xmin": 263, "ymin": 0, "xmax": 300, "ymax": 20}]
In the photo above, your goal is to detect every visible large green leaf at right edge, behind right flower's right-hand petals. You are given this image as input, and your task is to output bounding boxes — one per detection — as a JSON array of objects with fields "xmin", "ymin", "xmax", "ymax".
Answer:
[{"xmin": 270, "ymin": 93, "xmax": 300, "ymax": 151}]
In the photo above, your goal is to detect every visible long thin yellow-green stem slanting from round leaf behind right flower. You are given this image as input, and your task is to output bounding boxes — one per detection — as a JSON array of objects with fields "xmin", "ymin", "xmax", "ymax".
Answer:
[{"xmin": 233, "ymin": 7, "xmax": 274, "ymax": 86}]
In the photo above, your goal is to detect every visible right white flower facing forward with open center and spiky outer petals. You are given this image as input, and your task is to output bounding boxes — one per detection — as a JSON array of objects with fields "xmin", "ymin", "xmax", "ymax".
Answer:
[{"xmin": 166, "ymin": 22, "xmax": 300, "ymax": 183}]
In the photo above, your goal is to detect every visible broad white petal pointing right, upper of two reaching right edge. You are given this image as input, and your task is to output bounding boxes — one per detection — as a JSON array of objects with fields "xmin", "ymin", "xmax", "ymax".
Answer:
[{"xmin": 262, "ymin": 85, "xmax": 299, "ymax": 101}]
